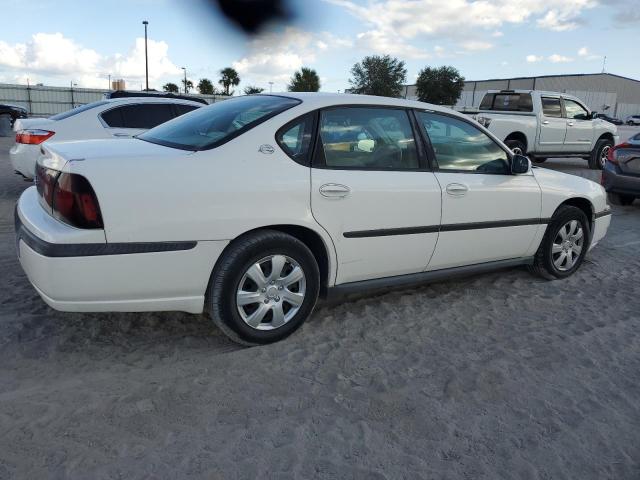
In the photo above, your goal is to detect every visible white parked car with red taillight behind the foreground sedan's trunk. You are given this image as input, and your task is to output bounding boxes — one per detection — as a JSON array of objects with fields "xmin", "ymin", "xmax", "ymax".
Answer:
[{"xmin": 9, "ymin": 97, "xmax": 203, "ymax": 179}]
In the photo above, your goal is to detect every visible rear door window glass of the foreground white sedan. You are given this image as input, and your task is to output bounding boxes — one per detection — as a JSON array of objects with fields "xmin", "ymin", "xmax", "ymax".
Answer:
[{"xmin": 320, "ymin": 107, "xmax": 419, "ymax": 170}]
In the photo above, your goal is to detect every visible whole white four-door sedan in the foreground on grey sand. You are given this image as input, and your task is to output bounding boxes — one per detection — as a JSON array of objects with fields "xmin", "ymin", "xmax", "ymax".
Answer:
[{"xmin": 16, "ymin": 93, "xmax": 611, "ymax": 344}]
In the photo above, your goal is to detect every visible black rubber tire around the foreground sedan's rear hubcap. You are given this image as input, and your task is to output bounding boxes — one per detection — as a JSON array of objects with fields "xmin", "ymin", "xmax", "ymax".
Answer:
[{"xmin": 205, "ymin": 230, "xmax": 320, "ymax": 345}]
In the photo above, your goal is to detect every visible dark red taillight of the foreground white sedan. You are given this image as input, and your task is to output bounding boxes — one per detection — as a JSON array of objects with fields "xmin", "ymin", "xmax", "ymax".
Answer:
[{"xmin": 36, "ymin": 164, "xmax": 104, "ymax": 228}]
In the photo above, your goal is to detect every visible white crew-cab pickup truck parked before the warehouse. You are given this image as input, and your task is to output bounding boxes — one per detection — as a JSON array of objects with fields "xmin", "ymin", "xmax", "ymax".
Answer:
[{"xmin": 476, "ymin": 90, "xmax": 618, "ymax": 169}]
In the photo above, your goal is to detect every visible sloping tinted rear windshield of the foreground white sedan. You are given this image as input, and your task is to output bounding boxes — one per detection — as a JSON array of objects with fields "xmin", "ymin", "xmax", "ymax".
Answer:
[{"xmin": 138, "ymin": 95, "xmax": 300, "ymax": 150}]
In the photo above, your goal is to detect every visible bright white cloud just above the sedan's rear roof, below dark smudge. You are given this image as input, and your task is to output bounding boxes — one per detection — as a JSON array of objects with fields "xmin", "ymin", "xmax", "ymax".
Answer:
[{"xmin": 232, "ymin": 28, "xmax": 353, "ymax": 90}]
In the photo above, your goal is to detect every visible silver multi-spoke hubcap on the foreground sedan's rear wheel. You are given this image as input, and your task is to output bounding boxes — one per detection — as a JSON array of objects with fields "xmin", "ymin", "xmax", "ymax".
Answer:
[{"xmin": 236, "ymin": 255, "xmax": 306, "ymax": 330}]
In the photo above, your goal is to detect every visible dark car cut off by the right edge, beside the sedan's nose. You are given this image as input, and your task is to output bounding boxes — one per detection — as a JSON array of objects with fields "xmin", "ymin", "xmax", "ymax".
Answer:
[{"xmin": 602, "ymin": 133, "xmax": 640, "ymax": 205}]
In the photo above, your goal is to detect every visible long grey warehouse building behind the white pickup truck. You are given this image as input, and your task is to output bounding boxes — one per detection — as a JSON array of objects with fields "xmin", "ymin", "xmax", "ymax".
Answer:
[{"xmin": 405, "ymin": 73, "xmax": 640, "ymax": 120}]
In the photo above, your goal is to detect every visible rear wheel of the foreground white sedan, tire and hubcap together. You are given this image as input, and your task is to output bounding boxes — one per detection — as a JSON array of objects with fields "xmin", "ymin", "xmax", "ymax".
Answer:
[{"xmin": 207, "ymin": 230, "xmax": 320, "ymax": 345}]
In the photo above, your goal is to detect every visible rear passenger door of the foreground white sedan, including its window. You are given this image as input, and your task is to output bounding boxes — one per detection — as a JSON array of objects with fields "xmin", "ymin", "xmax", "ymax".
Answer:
[{"xmin": 311, "ymin": 106, "xmax": 441, "ymax": 284}]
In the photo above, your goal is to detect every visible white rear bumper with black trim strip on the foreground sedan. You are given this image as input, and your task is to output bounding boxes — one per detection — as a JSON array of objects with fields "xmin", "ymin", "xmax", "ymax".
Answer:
[{"xmin": 15, "ymin": 187, "xmax": 227, "ymax": 313}]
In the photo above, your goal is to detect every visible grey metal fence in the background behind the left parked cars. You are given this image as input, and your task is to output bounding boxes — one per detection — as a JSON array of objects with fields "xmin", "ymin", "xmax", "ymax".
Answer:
[{"xmin": 0, "ymin": 83, "xmax": 228, "ymax": 117}]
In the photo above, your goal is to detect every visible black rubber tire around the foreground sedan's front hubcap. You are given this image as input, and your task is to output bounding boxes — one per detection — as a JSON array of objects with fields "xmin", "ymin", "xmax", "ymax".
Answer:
[{"xmin": 529, "ymin": 205, "xmax": 591, "ymax": 280}]
